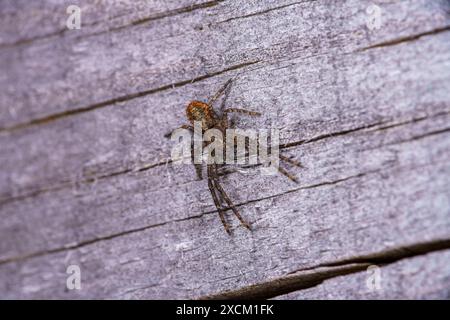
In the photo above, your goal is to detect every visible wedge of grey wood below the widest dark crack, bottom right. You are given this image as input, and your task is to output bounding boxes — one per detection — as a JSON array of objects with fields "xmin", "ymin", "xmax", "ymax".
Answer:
[{"xmin": 277, "ymin": 250, "xmax": 450, "ymax": 299}]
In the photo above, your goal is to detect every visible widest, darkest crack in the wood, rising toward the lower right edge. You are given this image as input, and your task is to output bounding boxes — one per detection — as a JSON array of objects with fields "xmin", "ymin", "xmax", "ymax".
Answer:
[{"xmin": 198, "ymin": 239, "xmax": 450, "ymax": 300}]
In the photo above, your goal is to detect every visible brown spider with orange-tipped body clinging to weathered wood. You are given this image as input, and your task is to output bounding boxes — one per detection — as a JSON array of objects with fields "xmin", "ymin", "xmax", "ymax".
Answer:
[{"xmin": 166, "ymin": 79, "xmax": 302, "ymax": 235}]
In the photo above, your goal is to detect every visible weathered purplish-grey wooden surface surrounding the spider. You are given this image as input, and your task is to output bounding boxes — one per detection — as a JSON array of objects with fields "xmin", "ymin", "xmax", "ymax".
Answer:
[{"xmin": 0, "ymin": 0, "xmax": 450, "ymax": 299}]
